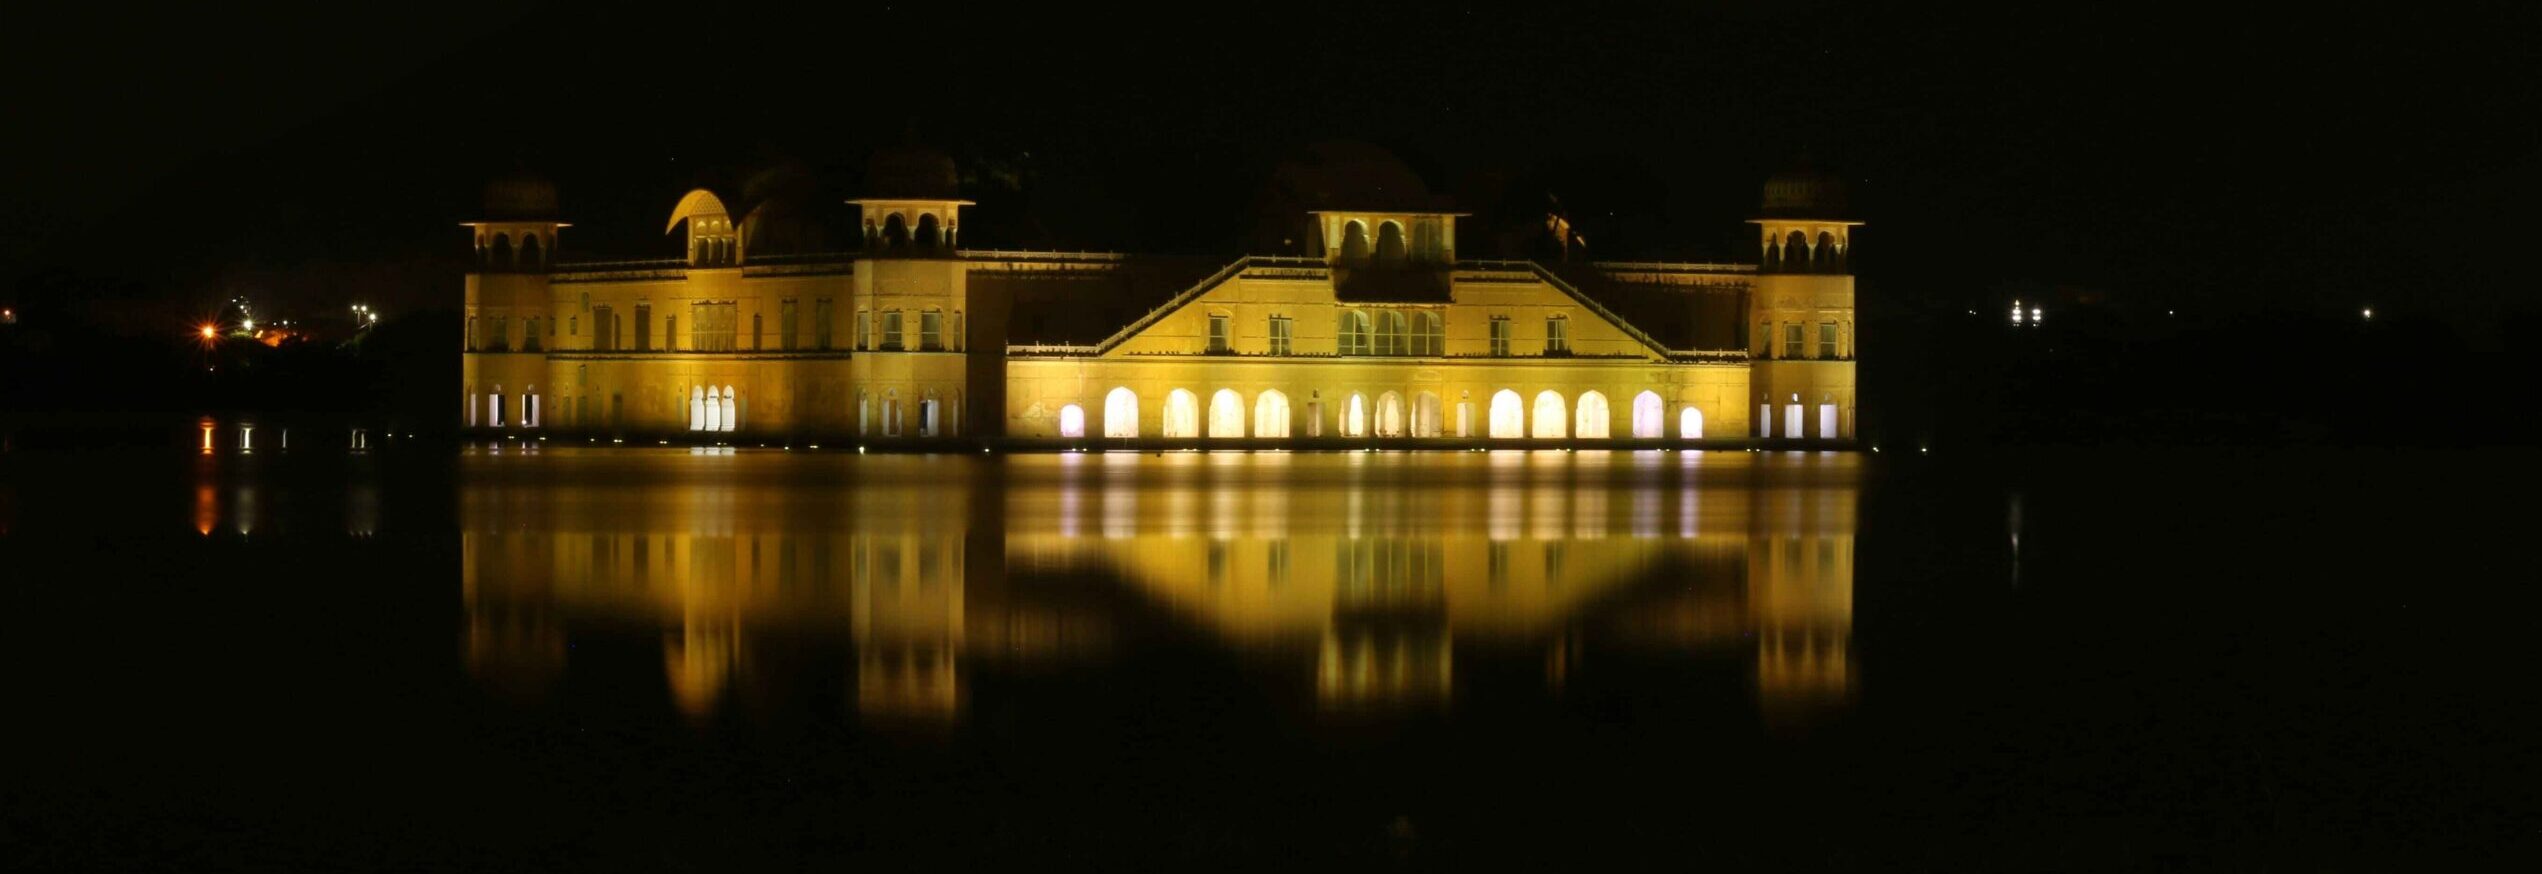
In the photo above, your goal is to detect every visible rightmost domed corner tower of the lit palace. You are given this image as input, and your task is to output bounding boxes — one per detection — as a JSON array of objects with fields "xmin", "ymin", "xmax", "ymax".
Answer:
[{"xmin": 1749, "ymin": 170, "xmax": 1861, "ymax": 442}]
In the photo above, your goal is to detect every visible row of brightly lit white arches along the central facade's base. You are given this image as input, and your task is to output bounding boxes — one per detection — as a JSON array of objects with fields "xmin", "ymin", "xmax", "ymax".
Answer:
[{"xmin": 1060, "ymin": 386, "xmax": 1703, "ymax": 440}]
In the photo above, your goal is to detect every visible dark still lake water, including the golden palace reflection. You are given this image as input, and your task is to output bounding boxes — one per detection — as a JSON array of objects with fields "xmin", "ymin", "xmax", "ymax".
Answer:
[{"xmin": 0, "ymin": 445, "xmax": 2542, "ymax": 871}]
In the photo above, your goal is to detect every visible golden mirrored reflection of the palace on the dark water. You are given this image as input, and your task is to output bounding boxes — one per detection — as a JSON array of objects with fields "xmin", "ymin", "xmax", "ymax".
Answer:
[{"xmin": 460, "ymin": 452, "xmax": 1858, "ymax": 722}]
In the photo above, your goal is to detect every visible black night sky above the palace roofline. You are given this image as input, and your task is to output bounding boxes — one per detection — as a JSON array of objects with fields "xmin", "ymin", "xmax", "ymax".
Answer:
[{"xmin": 0, "ymin": 3, "xmax": 2542, "ymax": 330}]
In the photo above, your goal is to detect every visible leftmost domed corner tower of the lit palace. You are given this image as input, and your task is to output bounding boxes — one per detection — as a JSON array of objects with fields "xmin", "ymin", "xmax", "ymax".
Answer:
[{"xmin": 460, "ymin": 173, "xmax": 567, "ymax": 429}]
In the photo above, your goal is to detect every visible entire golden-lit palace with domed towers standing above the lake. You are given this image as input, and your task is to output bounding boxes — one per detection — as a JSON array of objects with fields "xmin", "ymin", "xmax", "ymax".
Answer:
[{"xmin": 460, "ymin": 150, "xmax": 1856, "ymax": 445}]
